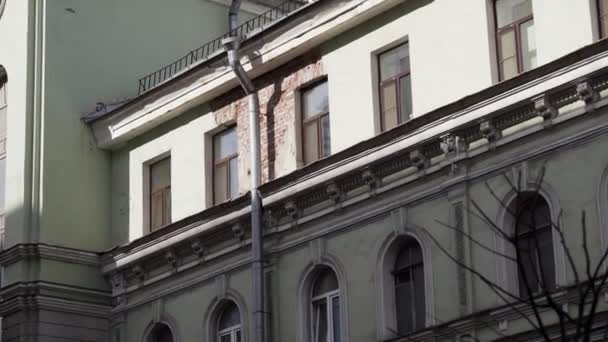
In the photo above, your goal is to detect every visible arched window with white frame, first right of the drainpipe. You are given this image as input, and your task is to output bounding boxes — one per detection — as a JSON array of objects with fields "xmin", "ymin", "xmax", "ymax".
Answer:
[{"xmin": 311, "ymin": 267, "xmax": 340, "ymax": 342}]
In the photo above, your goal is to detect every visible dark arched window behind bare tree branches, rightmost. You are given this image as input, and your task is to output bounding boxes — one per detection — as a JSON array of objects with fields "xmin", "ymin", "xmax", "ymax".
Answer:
[{"xmin": 511, "ymin": 192, "xmax": 555, "ymax": 297}]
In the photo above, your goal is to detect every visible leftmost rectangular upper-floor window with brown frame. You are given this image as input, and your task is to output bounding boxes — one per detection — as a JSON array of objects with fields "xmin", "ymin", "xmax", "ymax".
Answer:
[{"xmin": 150, "ymin": 157, "xmax": 171, "ymax": 231}]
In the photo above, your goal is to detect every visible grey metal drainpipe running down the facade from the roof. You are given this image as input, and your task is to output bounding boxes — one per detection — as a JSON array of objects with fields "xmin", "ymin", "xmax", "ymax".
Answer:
[{"xmin": 223, "ymin": 0, "xmax": 266, "ymax": 342}]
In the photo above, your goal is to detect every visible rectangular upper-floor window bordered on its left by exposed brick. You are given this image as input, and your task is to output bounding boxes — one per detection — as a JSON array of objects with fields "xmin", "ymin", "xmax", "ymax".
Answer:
[{"xmin": 302, "ymin": 81, "xmax": 331, "ymax": 165}]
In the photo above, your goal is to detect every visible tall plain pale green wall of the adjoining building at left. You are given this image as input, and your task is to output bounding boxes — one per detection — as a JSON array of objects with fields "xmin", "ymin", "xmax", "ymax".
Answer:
[{"xmin": 40, "ymin": 0, "xmax": 252, "ymax": 251}]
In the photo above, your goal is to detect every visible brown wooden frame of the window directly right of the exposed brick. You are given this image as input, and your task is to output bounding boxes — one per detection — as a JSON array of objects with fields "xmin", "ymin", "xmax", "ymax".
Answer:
[{"xmin": 298, "ymin": 77, "xmax": 331, "ymax": 165}]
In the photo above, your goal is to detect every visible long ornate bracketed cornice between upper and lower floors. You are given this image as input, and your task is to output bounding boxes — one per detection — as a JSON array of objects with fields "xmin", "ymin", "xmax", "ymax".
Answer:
[{"xmin": 103, "ymin": 54, "xmax": 608, "ymax": 293}]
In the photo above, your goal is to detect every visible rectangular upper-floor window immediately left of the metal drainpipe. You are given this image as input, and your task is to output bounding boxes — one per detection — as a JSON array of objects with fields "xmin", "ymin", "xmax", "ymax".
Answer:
[{"xmin": 213, "ymin": 127, "xmax": 239, "ymax": 204}]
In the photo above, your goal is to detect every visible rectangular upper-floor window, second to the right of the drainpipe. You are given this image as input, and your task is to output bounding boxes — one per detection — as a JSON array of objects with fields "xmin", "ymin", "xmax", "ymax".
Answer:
[{"xmin": 378, "ymin": 43, "xmax": 412, "ymax": 131}]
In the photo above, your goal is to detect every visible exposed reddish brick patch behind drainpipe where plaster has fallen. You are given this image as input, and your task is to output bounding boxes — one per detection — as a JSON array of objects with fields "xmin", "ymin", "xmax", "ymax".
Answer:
[{"xmin": 211, "ymin": 53, "xmax": 325, "ymax": 188}]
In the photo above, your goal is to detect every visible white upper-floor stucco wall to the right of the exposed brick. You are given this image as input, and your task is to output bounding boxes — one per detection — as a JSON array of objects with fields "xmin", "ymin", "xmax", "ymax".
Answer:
[{"xmin": 323, "ymin": 0, "xmax": 596, "ymax": 152}]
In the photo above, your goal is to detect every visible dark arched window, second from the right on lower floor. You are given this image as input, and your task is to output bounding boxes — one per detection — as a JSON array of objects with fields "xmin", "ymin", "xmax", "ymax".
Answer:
[{"xmin": 393, "ymin": 238, "xmax": 426, "ymax": 333}]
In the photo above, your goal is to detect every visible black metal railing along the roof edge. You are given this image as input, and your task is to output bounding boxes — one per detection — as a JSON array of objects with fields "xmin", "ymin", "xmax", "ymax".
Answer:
[{"xmin": 139, "ymin": 0, "xmax": 307, "ymax": 95}]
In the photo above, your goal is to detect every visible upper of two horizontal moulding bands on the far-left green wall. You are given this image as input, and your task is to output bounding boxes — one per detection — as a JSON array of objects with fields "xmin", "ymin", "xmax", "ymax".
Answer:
[{"xmin": 0, "ymin": 243, "xmax": 101, "ymax": 267}]
